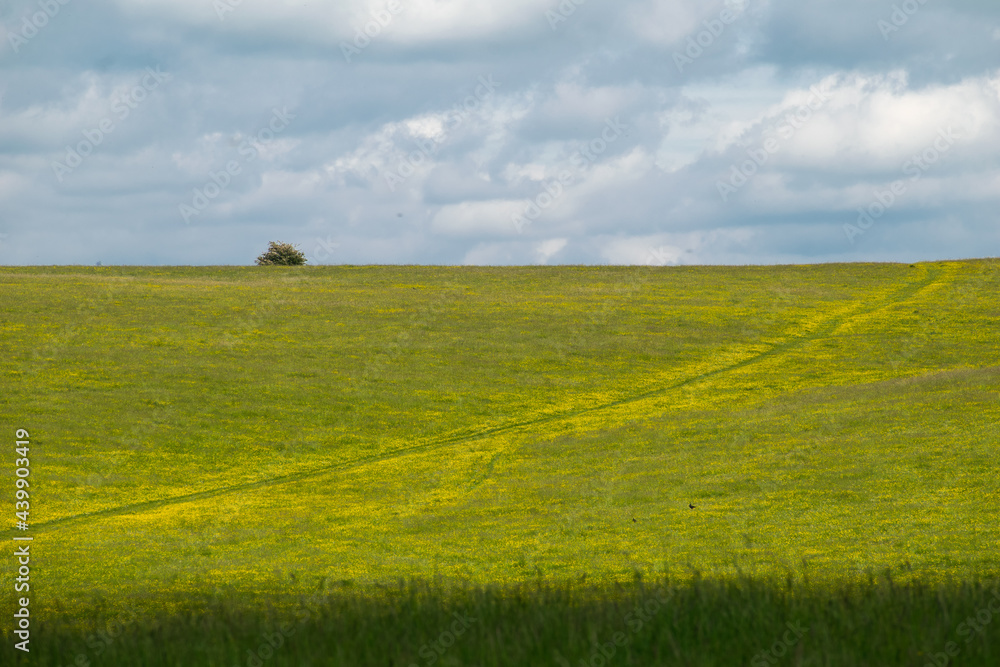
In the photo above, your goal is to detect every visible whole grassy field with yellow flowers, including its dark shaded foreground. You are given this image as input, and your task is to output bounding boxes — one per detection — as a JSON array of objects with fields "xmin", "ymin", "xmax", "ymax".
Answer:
[{"xmin": 0, "ymin": 260, "xmax": 1000, "ymax": 667}]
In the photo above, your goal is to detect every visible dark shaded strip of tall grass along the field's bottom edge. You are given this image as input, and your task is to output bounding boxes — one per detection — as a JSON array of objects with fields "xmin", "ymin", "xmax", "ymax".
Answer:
[{"xmin": 4, "ymin": 576, "xmax": 1000, "ymax": 667}]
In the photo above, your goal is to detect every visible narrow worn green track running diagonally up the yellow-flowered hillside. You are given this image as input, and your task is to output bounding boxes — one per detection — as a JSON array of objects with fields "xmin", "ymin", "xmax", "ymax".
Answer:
[{"xmin": 23, "ymin": 267, "xmax": 942, "ymax": 534}]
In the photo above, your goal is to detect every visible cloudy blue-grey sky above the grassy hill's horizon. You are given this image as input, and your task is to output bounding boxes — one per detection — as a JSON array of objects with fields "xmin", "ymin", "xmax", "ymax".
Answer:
[{"xmin": 0, "ymin": 0, "xmax": 1000, "ymax": 266}]
